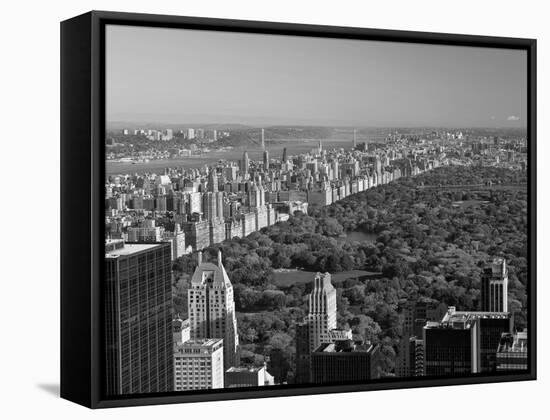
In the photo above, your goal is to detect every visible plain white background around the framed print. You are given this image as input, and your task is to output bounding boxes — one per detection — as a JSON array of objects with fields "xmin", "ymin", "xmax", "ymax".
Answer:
[{"xmin": 0, "ymin": 0, "xmax": 550, "ymax": 420}]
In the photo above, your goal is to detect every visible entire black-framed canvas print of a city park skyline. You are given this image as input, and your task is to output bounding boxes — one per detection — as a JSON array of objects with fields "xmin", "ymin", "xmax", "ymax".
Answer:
[{"xmin": 61, "ymin": 12, "xmax": 536, "ymax": 408}]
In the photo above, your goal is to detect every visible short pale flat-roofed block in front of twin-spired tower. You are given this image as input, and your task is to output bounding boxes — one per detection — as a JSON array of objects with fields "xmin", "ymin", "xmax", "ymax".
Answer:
[{"xmin": 174, "ymin": 338, "xmax": 224, "ymax": 391}]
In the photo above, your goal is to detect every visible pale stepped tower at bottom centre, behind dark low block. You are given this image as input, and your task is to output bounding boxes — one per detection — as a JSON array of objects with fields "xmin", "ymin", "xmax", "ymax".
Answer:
[{"xmin": 307, "ymin": 273, "xmax": 336, "ymax": 351}]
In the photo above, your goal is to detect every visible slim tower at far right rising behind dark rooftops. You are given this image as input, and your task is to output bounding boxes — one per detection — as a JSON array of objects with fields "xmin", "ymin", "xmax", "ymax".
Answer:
[{"xmin": 481, "ymin": 258, "xmax": 508, "ymax": 312}]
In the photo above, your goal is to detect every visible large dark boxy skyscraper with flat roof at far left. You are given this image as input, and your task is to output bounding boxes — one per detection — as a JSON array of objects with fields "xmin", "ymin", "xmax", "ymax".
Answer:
[{"xmin": 103, "ymin": 240, "xmax": 174, "ymax": 395}]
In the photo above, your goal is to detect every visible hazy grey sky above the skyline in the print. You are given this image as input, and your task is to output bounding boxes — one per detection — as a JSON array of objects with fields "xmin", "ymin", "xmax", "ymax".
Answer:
[{"xmin": 106, "ymin": 25, "xmax": 527, "ymax": 127}]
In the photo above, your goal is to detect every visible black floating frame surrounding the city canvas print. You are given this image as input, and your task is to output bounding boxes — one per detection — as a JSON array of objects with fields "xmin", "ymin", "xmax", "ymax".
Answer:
[{"xmin": 61, "ymin": 11, "xmax": 537, "ymax": 408}]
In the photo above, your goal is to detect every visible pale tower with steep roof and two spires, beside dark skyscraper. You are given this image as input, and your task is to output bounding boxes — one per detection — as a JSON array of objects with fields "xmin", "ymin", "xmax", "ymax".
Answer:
[{"xmin": 188, "ymin": 251, "xmax": 239, "ymax": 370}]
